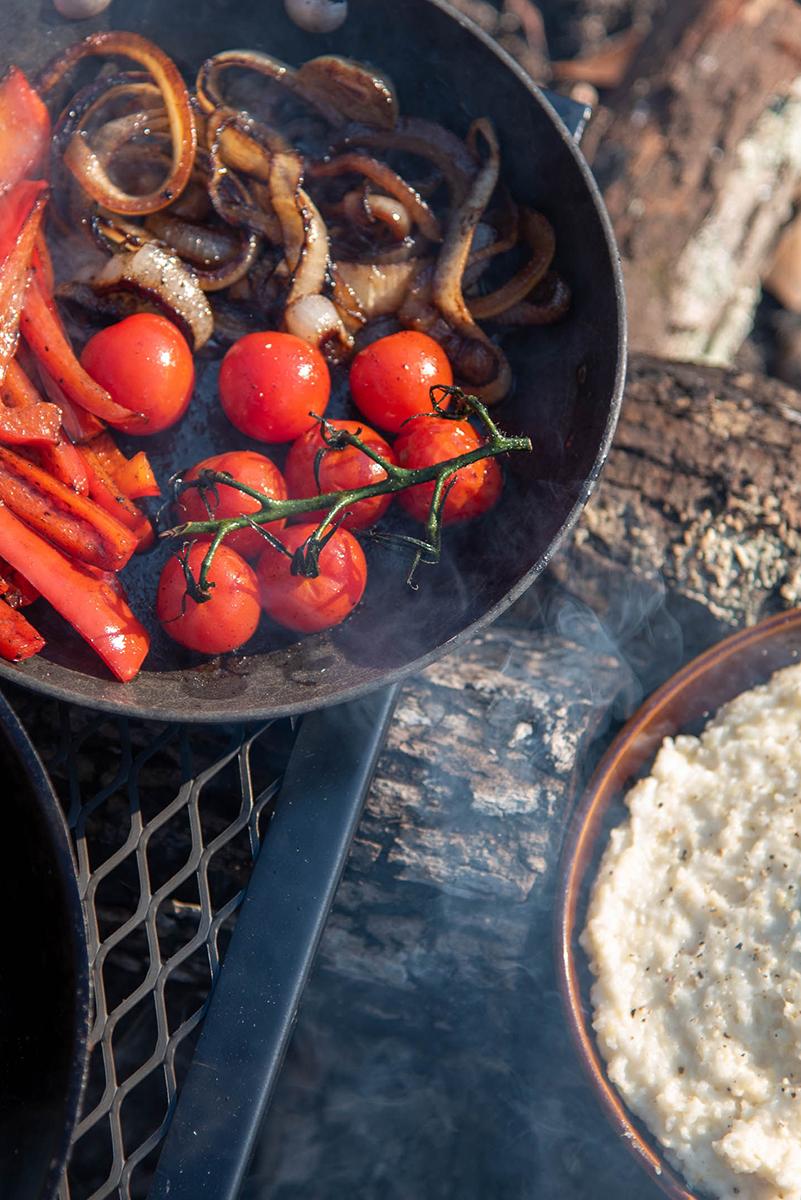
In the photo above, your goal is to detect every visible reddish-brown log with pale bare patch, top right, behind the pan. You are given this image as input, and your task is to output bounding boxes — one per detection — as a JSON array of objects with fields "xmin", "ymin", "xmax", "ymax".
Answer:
[{"xmin": 584, "ymin": 0, "xmax": 801, "ymax": 365}]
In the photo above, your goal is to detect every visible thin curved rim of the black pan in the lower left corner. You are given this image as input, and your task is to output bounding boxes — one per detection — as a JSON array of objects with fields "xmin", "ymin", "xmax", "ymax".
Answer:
[{"xmin": 0, "ymin": 692, "xmax": 90, "ymax": 1200}]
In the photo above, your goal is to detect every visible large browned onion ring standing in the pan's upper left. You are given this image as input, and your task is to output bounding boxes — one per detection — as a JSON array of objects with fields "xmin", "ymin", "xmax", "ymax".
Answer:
[{"xmin": 40, "ymin": 31, "xmax": 197, "ymax": 215}]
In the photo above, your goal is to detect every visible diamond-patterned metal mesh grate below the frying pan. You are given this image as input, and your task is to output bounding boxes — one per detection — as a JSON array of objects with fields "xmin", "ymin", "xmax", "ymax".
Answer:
[{"xmin": 8, "ymin": 695, "xmax": 293, "ymax": 1200}]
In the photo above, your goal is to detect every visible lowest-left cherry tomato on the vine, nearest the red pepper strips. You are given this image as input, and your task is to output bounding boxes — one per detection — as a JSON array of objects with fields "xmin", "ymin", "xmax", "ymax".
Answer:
[{"xmin": 156, "ymin": 541, "xmax": 261, "ymax": 654}]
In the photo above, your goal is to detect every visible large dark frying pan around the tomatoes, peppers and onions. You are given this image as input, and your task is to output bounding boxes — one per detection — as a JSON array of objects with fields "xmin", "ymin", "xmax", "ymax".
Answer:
[{"xmin": 0, "ymin": 0, "xmax": 625, "ymax": 721}]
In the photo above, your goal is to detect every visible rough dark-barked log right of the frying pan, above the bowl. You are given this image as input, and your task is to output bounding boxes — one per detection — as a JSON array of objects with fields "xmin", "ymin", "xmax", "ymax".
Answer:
[{"xmin": 553, "ymin": 355, "xmax": 801, "ymax": 625}]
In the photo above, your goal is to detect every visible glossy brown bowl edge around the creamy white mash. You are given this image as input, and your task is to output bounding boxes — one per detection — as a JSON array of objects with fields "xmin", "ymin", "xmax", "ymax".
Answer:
[{"xmin": 555, "ymin": 608, "xmax": 801, "ymax": 1200}]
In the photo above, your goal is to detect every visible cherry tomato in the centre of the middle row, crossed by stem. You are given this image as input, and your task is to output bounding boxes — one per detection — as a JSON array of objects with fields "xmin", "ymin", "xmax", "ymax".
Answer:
[{"xmin": 284, "ymin": 421, "xmax": 395, "ymax": 529}]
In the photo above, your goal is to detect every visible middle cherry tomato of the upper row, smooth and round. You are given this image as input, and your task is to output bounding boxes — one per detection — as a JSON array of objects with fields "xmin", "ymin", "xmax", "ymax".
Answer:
[{"xmin": 219, "ymin": 331, "xmax": 331, "ymax": 442}]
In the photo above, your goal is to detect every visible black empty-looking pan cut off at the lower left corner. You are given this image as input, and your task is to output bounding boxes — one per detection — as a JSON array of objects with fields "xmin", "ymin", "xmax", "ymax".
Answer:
[{"xmin": 0, "ymin": 695, "xmax": 89, "ymax": 1200}]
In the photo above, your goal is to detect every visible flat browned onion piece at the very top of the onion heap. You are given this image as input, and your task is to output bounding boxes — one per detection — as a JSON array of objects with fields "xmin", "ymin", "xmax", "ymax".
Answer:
[{"xmin": 293, "ymin": 54, "xmax": 399, "ymax": 130}]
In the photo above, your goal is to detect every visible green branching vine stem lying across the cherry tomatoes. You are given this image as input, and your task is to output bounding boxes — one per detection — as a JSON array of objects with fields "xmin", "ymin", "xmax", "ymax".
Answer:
[{"xmin": 159, "ymin": 385, "xmax": 531, "ymax": 601}]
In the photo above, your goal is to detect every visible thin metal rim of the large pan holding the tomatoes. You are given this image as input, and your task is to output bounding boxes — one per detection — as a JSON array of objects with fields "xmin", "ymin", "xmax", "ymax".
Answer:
[{"xmin": 0, "ymin": 0, "xmax": 627, "ymax": 725}]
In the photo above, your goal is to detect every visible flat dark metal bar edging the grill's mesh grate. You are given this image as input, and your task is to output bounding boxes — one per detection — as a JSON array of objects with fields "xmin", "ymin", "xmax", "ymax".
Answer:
[{"xmin": 150, "ymin": 688, "xmax": 396, "ymax": 1200}]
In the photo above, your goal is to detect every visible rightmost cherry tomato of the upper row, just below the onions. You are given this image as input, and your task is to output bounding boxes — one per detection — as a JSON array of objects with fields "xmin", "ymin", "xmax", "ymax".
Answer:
[{"xmin": 350, "ymin": 329, "xmax": 453, "ymax": 433}]
